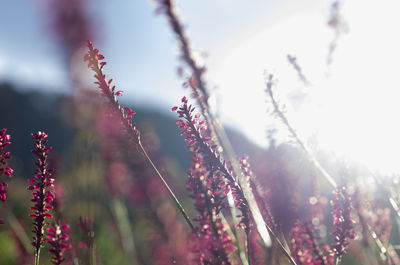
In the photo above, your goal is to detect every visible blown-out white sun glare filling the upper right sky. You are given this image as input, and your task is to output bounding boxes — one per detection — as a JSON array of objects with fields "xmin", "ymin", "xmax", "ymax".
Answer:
[{"xmin": 212, "ymin": 0, "xmax": 400, "ymax": 173}]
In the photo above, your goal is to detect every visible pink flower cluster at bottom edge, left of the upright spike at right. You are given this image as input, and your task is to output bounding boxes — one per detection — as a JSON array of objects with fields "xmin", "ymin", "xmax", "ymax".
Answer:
[{"xmin": 291, "ymin": 220, "xmax": 333, "ymax": 265}]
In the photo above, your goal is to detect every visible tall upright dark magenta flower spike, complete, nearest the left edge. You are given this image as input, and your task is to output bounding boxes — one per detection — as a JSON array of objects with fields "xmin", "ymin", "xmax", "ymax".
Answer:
[{"xmin": 28, "ymin": 132, "xmax": 54, "ymax": 254}]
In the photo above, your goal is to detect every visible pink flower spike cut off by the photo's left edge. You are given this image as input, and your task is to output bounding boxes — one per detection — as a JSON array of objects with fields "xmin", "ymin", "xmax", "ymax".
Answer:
[{"xmin": 0, "ymin": 129, "xmax": 14, "ymax": 203}]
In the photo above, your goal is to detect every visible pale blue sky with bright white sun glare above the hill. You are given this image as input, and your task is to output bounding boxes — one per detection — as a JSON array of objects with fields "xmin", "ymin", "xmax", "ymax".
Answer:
[{"xmin": 0, "ymin": 0, "xmax": 400, "ymax": 172}]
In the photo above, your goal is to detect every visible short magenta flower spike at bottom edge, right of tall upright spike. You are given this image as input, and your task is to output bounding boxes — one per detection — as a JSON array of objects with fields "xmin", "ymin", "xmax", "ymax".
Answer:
[{"xmin": 46, "ymin": 223, "xmax": 71, "ymax": 265}]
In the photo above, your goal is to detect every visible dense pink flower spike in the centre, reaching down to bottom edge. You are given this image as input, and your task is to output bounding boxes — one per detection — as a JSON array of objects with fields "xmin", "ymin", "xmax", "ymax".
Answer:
[{"xmin": 172, "ymin": 97, "xmax": 235, "ymax": 264}]
